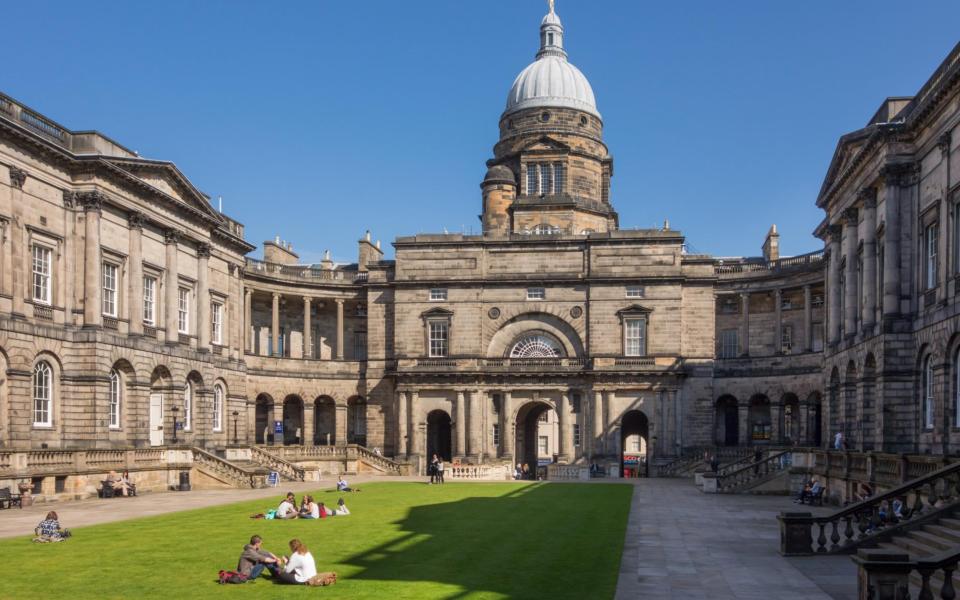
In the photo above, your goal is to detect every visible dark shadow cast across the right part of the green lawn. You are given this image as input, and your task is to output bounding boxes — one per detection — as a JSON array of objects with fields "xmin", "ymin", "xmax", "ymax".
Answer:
[{"xmin": 344, "ymin": 484, "xmax": 629, "ymax": 598}]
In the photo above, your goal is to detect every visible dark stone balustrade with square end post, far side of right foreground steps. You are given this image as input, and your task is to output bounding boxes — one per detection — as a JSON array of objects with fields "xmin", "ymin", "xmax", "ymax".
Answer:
[{"xmin": 778, "ymin": 463, "xmax": 960, "ymax": 556}]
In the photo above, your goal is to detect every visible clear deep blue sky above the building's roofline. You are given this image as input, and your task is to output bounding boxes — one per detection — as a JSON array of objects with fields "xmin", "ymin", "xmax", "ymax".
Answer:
[{"xmin": 0, "ymin": 0, "xmax": 960, "ymax": 262}]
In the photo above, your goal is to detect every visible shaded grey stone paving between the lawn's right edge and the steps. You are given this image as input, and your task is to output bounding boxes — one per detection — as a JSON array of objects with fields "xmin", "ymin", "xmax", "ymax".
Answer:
[{"xmin": 616, "ymin": 479, "xmax": 857, "ymax": 600}]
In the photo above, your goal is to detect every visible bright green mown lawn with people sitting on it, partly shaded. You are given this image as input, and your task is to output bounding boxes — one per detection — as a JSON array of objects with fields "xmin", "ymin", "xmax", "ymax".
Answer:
[{"xmin": 0, "ymin": 483, "xmax": 632, "ymax": 600}]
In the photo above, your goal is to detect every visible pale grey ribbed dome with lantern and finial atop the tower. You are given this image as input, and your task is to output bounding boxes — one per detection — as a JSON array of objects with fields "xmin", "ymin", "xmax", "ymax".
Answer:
[{"xmin": 503, "ymin": 5, "xmax": 600, "ymax": 118}]
